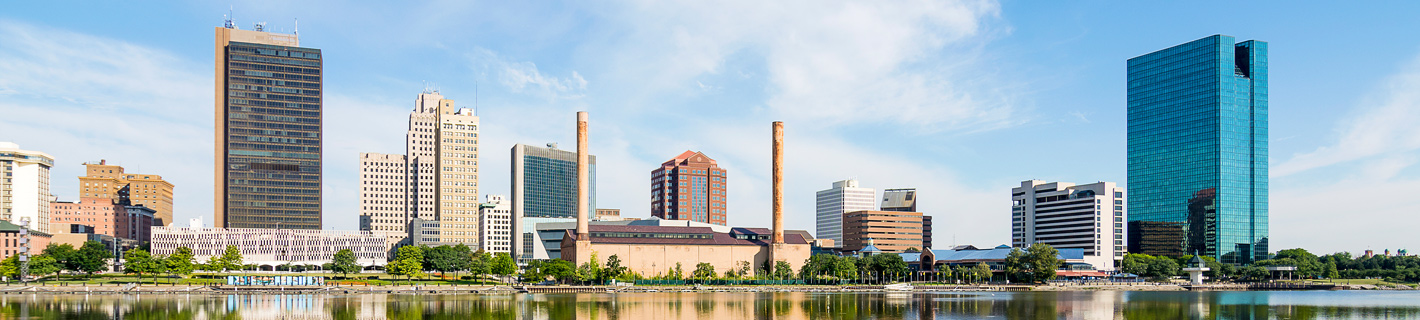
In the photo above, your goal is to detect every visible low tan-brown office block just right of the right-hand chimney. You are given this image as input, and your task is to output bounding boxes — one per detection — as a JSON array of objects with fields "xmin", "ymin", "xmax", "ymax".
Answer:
[{"xmin": 843, "ymin": 210, "xmax": 923, "ymax": 252}]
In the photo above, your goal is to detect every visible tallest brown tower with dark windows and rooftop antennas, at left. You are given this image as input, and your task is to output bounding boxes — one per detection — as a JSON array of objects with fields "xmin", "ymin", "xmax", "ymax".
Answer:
[{"xmin": 213, "ymin": 20, "xmax": 322, "ymax": 229}]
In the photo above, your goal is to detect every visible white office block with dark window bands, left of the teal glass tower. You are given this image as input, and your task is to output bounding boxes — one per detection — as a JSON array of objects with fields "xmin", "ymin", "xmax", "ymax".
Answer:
[{"xmin": 1011, "ymin": 181, "xmax": 1127, "ymax": 270}]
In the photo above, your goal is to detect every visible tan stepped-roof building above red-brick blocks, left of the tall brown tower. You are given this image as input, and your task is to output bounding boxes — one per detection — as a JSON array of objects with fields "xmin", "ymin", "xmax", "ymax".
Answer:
[{"xmin": 80, "ymin": 159, "xmax": 173, "ymax": 226}]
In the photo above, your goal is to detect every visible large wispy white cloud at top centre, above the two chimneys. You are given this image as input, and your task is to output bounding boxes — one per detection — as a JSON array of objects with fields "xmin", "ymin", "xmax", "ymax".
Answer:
[{"xmin": 608, "ymin": 1, "xmax": 1021, "ymax": 132}]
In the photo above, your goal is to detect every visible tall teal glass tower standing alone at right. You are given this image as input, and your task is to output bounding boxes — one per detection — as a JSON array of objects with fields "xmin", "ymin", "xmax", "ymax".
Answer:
[{"xmin": 1116, "ymin": 34, "xmax": 1268, "ymax": 263}]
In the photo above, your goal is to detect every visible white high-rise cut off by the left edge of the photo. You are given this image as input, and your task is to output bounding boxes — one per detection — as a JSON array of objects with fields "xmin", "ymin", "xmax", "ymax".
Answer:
[{"xmin": 0, "ymin": 142, "xmax": 54, "ymax": 233}]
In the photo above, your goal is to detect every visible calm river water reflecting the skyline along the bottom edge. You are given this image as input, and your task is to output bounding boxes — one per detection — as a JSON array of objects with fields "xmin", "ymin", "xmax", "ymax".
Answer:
[{"xmin": 0, "ymin": 292, "xmax": 1420, "ymax": 320}]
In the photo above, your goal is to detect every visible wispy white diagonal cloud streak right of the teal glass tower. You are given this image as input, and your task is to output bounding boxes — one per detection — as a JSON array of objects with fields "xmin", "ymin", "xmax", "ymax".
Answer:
[{"xmin": 1272, "ymin": 57, "xmax": 1420, "ymax": 176}]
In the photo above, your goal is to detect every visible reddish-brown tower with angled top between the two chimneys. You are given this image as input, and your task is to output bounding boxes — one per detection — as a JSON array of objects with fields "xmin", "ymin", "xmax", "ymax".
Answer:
[{"xmin": 650, "ymin": 151, "xmax": 726, "ymax": 226}]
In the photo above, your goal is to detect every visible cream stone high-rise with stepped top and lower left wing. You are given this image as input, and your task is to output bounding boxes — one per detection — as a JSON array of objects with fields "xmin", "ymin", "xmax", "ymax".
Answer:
[{"xmin": 359, "ymin": 90, "xmax": 480, "ymax": 247}]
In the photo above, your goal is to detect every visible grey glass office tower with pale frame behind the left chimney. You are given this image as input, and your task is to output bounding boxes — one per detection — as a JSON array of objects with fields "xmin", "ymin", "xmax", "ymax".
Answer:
[{"xmin": 510, "ymin": 144, "xmax": 596, "ymax": 259}]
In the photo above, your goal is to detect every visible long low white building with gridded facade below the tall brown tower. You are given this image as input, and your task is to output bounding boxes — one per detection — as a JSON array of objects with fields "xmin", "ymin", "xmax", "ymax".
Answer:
[{"xmin": 151, "ymin": 226, "xmax": 388, "ymax": 267}]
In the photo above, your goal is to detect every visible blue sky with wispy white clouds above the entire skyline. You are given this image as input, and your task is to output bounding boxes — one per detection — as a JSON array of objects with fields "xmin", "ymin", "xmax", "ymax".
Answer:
[{"xmin": 0, "ymin": 1, "xmax": 1420, "ymax": 252}]
